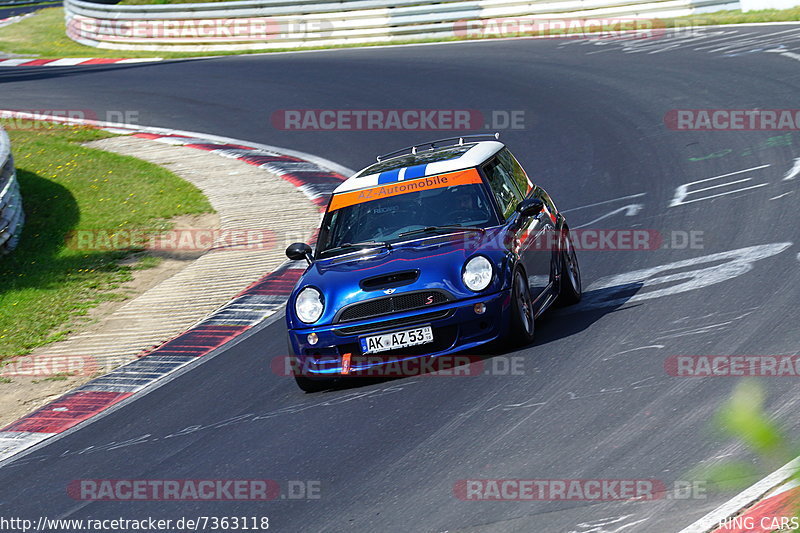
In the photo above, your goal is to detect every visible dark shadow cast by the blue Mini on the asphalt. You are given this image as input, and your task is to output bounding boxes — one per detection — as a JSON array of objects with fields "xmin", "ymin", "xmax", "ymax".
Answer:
[{"xmin": 300, "ymin": 282, "xmax": 643, "ymax": 392}]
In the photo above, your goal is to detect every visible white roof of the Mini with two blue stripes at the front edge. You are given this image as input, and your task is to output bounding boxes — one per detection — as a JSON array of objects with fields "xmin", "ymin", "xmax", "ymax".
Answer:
[{"xmin": 333, "ymin": 141, "xmax": 505, "ymax": 194}]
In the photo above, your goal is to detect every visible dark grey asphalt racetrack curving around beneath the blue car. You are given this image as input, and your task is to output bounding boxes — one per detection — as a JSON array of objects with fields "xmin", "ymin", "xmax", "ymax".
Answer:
[{"xmin": 0, "ymin": 25, "xmax": 800, "ymax": 533}]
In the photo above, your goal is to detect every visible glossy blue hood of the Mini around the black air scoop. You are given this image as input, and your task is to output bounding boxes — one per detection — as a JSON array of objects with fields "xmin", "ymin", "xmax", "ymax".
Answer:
[{"xmin": 287, "ymin": 228, "xmax": 508, "ymax": 327}]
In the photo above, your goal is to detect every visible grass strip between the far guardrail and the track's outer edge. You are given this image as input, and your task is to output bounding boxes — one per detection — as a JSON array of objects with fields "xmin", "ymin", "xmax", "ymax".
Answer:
[{"xmin": 0, "ymin": 5, "xmax": 800, "ymax": 58}]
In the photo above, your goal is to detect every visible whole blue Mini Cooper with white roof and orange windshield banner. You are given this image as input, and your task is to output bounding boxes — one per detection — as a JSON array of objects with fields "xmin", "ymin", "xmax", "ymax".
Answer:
[{"xmin": 286, "ymin": 134, "xmax": 581, "ymax": 392}]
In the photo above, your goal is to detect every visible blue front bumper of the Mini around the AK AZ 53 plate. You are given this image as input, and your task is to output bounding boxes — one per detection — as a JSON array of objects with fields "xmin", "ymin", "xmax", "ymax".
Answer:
[{"xmin": 289, "ymin": 290, "xmax": 511, "ymax": 378}]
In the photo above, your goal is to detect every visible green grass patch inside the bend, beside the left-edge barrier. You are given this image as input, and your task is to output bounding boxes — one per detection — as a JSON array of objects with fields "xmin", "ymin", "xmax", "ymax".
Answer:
[{"xmin": 0, "ymin": 121, "xmax": 212, "ymax": 360}]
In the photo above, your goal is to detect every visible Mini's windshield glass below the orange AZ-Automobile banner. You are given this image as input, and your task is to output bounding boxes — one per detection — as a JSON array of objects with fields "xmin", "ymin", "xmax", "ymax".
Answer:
[{"xmin": 319, "ymin": 179, "xmax": 497, "ymax": 257}]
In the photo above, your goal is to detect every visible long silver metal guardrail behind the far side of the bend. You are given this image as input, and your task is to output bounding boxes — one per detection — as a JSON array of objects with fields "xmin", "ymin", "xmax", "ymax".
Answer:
[{"xmin": 64, "ymin": 0, "xmax": 739, "ymax": 52}]
